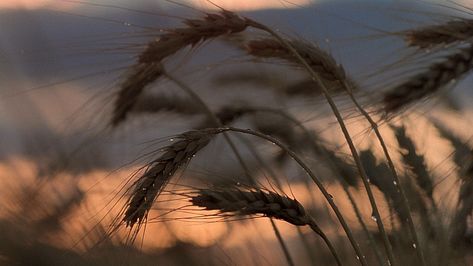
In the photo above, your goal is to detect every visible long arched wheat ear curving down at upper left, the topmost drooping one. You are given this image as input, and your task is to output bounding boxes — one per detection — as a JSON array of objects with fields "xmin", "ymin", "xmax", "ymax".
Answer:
[{"xmin": 111, "ymin": 10, "xmax": 248, "ymax": 126}]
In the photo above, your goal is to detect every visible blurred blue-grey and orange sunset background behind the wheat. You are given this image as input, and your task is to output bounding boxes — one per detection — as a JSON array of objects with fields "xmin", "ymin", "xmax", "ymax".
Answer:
[{"xmin": 0, "ymin": 0, "xmax": 473, "ymax": 265}]
